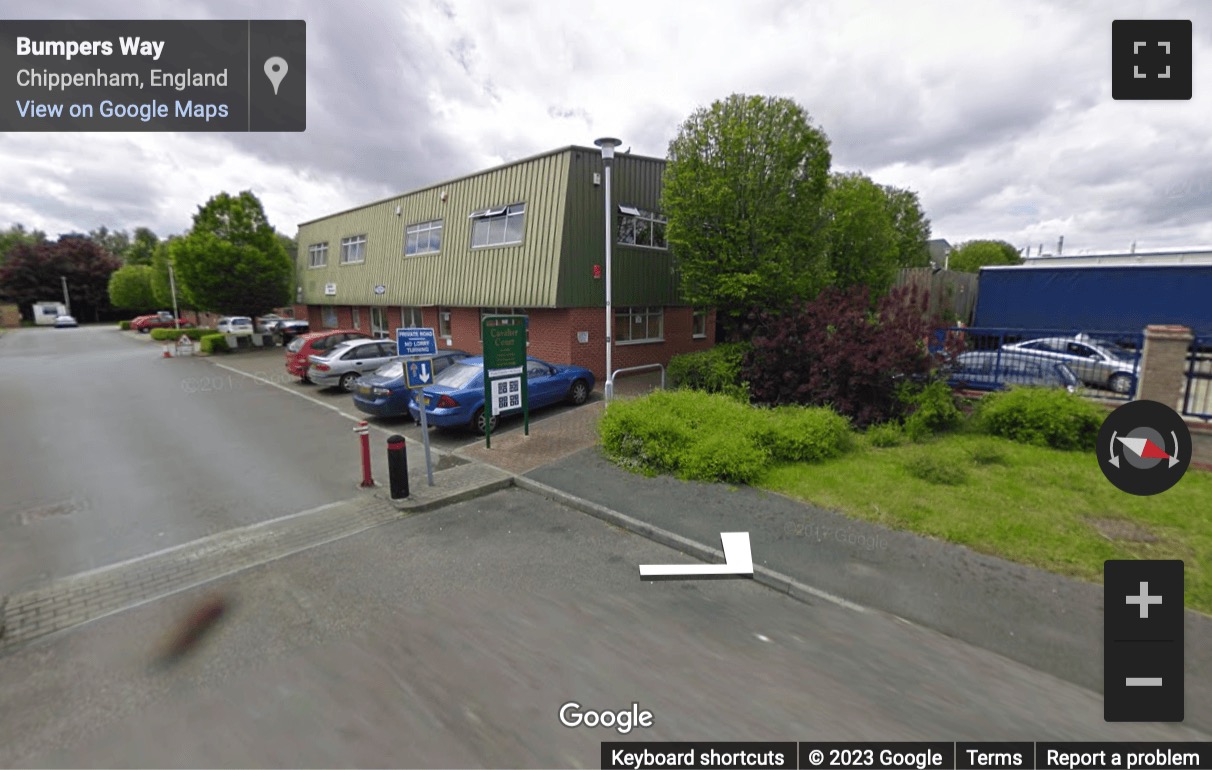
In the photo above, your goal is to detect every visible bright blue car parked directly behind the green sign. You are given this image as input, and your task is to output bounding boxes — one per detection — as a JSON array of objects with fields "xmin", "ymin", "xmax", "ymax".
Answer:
[{"xmin": 408, "ymin": 355, "xmax": 594, "ymax": 435}]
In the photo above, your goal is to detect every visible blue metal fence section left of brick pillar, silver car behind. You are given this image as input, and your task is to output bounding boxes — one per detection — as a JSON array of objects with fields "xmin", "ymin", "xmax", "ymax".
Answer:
[{"xmin": 931, "ymin": 326, "xmax": 1144, "ymax": 400}]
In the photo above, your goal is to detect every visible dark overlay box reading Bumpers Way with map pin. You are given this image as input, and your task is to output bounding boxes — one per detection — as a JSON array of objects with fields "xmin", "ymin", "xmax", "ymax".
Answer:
[{"xmin": 0, "ymin": 21, "xmax": 307, "ymax": 132}]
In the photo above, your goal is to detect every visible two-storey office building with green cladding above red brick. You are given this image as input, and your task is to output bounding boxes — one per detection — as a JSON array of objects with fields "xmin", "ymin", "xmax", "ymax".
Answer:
[{"xmin": 296, "ymin": 147, "xmax": 714, "ymax": 380}]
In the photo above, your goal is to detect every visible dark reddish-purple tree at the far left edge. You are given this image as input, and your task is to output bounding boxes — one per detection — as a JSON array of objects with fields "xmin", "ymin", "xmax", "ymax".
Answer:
[{"xmin": 0, "ymin": 235, "xmax": 121, "ymax": 320}]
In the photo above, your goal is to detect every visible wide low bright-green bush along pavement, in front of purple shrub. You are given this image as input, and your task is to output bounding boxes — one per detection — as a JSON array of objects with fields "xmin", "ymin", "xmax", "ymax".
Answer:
[{"xmin": 598, "ymin": 390, "xmax": 853, "ymax": 484}]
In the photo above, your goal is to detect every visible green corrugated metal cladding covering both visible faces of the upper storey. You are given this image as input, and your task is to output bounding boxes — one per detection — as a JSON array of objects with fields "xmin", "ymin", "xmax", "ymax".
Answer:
[{"xmin": 297, "ymin": 148, "xmax": 676, "ymax": 308}]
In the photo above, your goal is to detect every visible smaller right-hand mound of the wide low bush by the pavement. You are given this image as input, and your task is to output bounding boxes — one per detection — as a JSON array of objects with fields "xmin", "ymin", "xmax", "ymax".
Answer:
[{"xmin": 745, "ymin": 406, "xmax": 854, "ymax": 462}]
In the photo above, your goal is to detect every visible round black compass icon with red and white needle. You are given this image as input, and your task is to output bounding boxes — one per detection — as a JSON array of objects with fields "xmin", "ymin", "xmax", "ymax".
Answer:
[{"xmin": 1094, "ymin": 401, "xmax": 1191, "ymax": 496}]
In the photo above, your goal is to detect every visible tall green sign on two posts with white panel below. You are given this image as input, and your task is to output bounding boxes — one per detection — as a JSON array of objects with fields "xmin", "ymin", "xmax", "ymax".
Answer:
[{"xmin": 481, "ymin": 315, "xmax": 530, "ymax": 449}]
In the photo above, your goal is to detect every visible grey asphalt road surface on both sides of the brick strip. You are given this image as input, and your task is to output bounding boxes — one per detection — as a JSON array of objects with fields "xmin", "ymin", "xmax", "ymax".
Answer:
[{"xmin": 0, "ymin": 327, "xmax": 1208, "ymax": 768}]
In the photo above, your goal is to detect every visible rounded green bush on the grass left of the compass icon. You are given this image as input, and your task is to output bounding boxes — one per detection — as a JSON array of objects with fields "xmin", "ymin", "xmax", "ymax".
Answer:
[{"xmin": 976, "ymin": 388, "xmax": 1107, "ymax": 450}]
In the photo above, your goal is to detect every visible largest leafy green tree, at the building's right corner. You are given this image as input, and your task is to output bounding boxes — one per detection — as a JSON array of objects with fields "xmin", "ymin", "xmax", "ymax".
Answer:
[{"xmin": 662, "ymin": 93, "xmax": 831, "ymax": 337}]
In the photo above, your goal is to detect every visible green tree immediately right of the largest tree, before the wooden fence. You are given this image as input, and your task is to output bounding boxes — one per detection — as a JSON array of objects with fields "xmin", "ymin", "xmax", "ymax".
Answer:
[{"xmin": 824, "ymin": 172, "xmax": 899, "ymax": 297}]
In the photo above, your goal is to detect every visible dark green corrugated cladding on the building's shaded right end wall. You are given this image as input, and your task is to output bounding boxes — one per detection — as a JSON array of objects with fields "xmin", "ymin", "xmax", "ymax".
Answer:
[{"xmin": 559, "ymin": 148, "xmax": 679, "ymax": 307}]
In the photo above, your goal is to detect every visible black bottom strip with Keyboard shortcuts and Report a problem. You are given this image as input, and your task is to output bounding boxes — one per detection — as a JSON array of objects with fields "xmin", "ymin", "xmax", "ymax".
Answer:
[{"xmin": 601, "ymin": 741, "xmax": 1212, "ymax": 770}]
